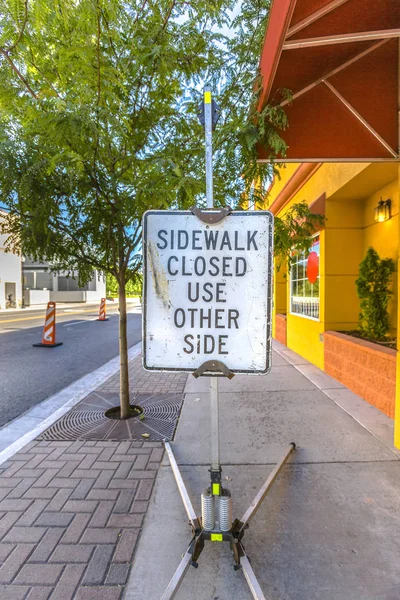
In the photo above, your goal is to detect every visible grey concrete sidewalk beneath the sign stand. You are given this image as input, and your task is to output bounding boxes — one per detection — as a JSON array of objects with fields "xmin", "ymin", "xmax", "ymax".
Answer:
[{"xmin": 124, "ymin": 345, "xmax": 400, "ymax": 600}]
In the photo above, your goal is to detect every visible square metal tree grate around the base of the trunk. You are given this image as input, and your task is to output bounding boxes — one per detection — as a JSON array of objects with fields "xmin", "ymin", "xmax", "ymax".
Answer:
[{"xmin": 37, "ymin": 392, "xmax": 183, "ymax": 442}]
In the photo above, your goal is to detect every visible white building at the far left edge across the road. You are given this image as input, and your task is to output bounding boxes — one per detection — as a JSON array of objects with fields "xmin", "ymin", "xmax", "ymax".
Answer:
[{"xmin": 0, "ymin": 210, "xmax": 22, "ymax": 309}]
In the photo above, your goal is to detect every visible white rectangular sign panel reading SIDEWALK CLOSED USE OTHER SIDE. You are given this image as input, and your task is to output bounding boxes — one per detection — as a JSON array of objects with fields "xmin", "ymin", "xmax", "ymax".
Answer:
[{"xmin": 143, "ymin": 211, "xmax": 273, "ymax": 373}]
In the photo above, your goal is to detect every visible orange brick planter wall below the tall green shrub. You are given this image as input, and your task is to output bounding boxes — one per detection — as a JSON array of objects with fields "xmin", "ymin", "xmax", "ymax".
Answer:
[{"xmin": 324, "ymin": 331, "xmax": 397, "ymax": 419}]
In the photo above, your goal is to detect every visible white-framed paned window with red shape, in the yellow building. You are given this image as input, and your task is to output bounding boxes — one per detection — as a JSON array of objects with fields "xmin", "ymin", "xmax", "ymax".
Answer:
[{"xmin": 290, "ymin": 235, "xmax": 320, "ymax": 319}]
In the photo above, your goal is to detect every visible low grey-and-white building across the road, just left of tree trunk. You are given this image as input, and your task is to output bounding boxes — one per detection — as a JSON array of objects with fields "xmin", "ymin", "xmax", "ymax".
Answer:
[{"xmin": 23, "ymin": 258, "xmax": 106, "ymax": 306}]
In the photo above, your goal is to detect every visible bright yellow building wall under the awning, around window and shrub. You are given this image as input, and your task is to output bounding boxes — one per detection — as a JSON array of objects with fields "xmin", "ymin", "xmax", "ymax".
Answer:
[{"xmin": 264, "ymin": 163, "xmax": 400, "ymax": 380}]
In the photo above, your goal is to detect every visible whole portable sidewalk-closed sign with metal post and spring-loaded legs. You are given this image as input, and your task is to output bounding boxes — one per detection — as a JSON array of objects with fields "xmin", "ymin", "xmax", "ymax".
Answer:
[{"xmin": 143, "ymin": 88, "xmax": 295, "ymax": 600}]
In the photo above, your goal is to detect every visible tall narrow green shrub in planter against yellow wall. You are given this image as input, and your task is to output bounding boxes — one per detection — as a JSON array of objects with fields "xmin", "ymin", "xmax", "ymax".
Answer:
[{"xmin": 356, "ymin": 248, "xmax": 395, "ymax": 341}]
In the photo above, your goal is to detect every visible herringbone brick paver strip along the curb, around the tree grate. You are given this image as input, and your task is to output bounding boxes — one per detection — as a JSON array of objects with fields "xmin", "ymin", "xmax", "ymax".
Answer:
[{"xmin": 0, "ymin": 358, "xmax": 186, "ymax": 600}]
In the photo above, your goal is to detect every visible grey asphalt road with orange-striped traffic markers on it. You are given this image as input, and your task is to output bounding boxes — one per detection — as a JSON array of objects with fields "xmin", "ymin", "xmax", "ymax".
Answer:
[{"xmin": 0, "ymin": 305, "xmax": 142, "ymax": 426}]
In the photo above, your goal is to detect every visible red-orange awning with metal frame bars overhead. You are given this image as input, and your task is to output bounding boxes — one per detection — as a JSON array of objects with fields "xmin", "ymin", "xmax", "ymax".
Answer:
[{"xmin": 259, "ymin": 0, "xmax": 400, "ymax": 162}]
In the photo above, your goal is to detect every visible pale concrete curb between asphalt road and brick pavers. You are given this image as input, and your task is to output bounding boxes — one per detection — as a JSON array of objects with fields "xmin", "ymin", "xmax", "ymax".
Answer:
[{"xmin": 0, "ymin": 342, "xmax": 142, "ymax": 465}]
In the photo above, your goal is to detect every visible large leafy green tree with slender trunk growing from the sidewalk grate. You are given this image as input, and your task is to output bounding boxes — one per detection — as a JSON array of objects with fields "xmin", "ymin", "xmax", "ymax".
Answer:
[{"xmin": 0, "ymin": 0, "xmax": 316, "ymax": 418}]
